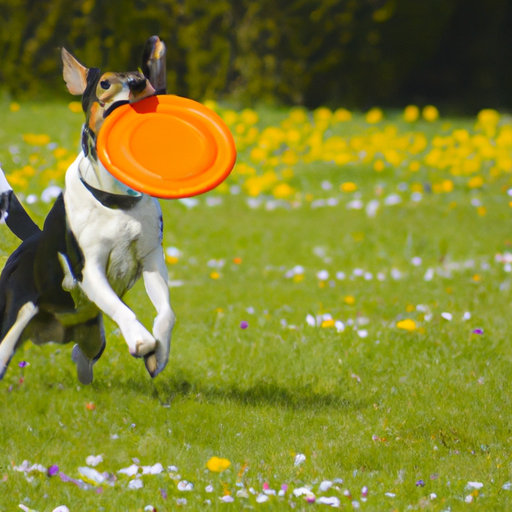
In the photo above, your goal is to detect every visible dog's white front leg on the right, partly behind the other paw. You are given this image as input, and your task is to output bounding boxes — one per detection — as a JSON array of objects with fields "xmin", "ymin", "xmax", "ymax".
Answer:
[{"xmin": 142, "ymin": 246, "xmax": 176, "ymax": 378}]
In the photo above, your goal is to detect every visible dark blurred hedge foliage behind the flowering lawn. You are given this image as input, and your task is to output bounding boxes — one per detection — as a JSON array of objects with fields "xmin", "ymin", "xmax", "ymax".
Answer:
[{"xmin": 0, "ymin": 0, "xmax": 512, "ymax": 107}]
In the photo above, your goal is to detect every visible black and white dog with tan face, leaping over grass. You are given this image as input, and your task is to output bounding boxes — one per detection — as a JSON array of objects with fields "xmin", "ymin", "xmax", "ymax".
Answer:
[{"xmin": 0, "ymin": 36, "xmax": 175, "ymax": 384}]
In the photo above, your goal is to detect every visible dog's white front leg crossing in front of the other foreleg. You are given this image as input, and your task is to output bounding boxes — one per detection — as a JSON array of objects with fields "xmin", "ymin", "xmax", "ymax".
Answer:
[{"xmin": 79, "ymin": 254, "xmax": 155, "ymax": 357}]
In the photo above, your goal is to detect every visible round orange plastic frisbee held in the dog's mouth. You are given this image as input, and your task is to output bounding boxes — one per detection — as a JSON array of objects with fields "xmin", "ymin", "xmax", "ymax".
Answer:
[{"xmin": 96, "ymin": 95, "xmax": 236, "ymax": 199}]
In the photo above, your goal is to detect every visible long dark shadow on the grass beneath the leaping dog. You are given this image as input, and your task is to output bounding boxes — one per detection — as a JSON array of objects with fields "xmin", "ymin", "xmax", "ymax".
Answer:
[{"xmin": 109, "ymin": 375, "xmax": 365, "ymax": 410}]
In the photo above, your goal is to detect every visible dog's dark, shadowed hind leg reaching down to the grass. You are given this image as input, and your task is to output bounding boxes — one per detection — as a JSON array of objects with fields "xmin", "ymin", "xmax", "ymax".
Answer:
[{"xmin": 71, "ymin": 313, "xmax": 106, "ymax": 385}]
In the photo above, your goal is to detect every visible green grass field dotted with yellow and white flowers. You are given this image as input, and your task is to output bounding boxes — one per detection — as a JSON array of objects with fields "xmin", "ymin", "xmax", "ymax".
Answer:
[{"xmin": 0, "ymin": 95, "xmax": 512, "ymax": 512}]
